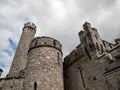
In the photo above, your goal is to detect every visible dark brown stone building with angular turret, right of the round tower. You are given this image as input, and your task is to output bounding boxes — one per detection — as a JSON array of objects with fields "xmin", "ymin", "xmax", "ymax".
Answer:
[{"xmin": 64, "ymin": 22, "xmax": 120, "ymax": 90}]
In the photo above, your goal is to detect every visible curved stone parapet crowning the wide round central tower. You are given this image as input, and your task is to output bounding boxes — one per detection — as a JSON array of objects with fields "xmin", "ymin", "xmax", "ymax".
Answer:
[{"xmin": 29, "ymin": 36, "xmax": 62, "ymax": 52}]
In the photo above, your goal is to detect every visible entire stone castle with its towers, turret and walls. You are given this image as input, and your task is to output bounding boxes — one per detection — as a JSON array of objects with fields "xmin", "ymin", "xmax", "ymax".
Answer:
[{"xmin": 0, "ymin": 22, "xmax": 120, "ymax": 90}]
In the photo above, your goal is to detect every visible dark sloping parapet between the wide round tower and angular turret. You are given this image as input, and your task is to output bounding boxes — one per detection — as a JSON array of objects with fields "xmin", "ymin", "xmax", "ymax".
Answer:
[{"xmin": 64, "ymin": 44, "xmax": 84, "ymax": 67}]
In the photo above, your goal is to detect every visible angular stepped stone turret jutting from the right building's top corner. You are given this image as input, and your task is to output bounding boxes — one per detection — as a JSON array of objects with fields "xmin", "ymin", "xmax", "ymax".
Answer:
[{"xmin": 79, "ymin": 22, "xmax": 105, "ymax": 59}]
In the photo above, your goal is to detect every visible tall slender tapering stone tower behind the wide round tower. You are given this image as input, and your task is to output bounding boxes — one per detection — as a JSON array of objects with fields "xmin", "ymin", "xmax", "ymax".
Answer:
[{"xmin": 7, "ymin": 22, "xmax": 36, "ymax": 77}]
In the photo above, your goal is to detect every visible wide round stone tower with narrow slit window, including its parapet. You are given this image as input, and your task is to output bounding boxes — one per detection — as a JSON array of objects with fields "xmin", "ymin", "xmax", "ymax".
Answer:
[{"xmin": 24, "ymin": 37, "xmax": 63, "ymax": 90}]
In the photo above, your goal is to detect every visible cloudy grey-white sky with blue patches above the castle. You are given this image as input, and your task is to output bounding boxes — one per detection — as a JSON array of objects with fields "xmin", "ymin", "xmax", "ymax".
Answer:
[{"xmin": 0, "ymin": 0, "xmax": 120, "ymax": 77}]
